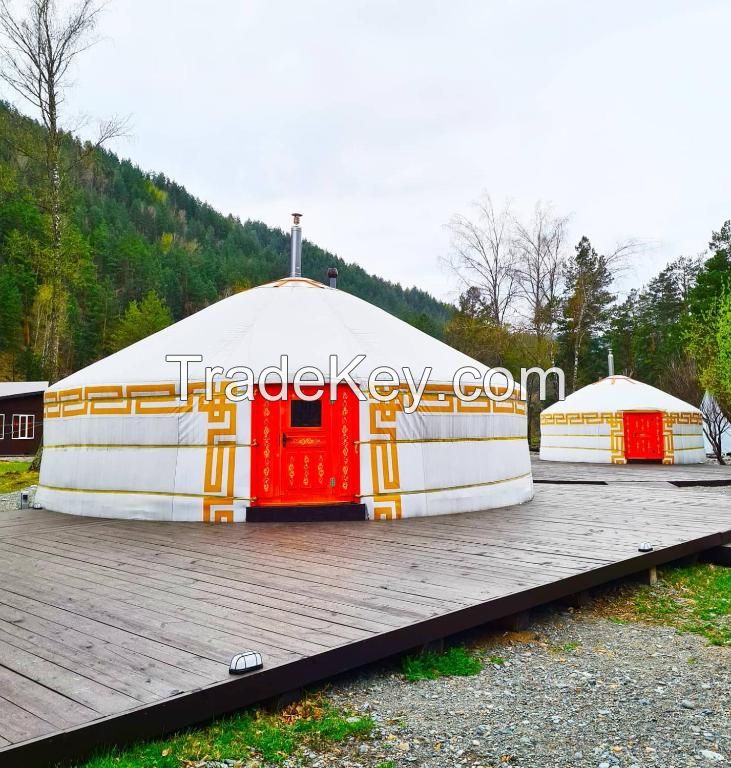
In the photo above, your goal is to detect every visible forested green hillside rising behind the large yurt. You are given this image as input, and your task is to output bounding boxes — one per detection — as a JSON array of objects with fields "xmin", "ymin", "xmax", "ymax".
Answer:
[{"xmin": 0, "ymin": 102, "xmax": 451, "ymax": 379}]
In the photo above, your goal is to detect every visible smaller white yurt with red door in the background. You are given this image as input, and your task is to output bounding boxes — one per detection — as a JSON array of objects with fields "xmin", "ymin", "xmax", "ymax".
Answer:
[{"xmin": 541, "ymin": 376, "xmax": 706, "ymax": 464}]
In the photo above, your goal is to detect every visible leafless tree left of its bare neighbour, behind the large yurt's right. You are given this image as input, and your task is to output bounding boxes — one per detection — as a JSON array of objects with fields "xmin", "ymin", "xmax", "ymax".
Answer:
[{"xmin": 448, "ymin": 195, "xmax": 518, "ymax": 327}]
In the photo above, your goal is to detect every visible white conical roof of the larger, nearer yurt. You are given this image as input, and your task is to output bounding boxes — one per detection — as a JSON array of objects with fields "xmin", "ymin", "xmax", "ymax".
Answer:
[{"xmin": 50, "ymin": 278, "xmax": 501, "ymax": 390}]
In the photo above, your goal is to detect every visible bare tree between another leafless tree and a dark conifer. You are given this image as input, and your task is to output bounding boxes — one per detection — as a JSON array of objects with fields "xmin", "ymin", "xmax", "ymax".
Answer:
[{"xmin": 513, "ymin": 203, "xmax": 568, "ymax": 338}]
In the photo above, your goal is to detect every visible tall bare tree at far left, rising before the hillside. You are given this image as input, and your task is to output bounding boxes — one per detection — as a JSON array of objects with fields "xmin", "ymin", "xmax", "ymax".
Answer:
[{"xmin": 0, "ymin": 0, "xmax": 124, "ymax": 381}]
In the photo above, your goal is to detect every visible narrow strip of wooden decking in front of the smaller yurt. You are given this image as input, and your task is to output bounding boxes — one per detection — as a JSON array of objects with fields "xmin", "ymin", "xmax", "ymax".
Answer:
[{"xmin": 531, "ymin": 454, "xmax": 731, "ymax": 487}]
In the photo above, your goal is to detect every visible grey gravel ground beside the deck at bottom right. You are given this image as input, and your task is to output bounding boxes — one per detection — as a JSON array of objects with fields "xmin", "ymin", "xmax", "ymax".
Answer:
[{"xmin": 318, "ymin": 612, "xmax": 731, "ymax": 768}]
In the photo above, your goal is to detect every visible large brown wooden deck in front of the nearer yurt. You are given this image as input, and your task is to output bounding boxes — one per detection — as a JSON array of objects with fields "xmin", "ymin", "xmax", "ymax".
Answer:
[{"xmin": 0, "ymin": 484, "xmax": 731, "ymax": 767}]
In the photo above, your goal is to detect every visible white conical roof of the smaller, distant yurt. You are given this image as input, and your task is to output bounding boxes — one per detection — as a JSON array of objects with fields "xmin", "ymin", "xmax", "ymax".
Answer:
[{"xmin": 543, "ymin": 376, "xmax": 700, "ymax": 413}]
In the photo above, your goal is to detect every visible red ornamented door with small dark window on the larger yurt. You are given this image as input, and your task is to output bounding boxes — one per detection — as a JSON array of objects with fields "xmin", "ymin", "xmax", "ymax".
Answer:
[{"xmin": 251, "ymin": 385, "xmax": 360, "ymax": 506}]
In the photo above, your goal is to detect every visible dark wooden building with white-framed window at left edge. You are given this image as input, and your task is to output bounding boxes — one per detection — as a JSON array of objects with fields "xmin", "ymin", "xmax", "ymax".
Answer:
[{"xmin": 0, "ymin": 381, "xmax": 48, "ymax": 456}]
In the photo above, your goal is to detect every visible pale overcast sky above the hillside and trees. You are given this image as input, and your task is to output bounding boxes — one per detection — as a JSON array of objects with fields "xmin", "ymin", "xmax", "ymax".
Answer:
[{"xmin": 7, "ymin": 0, "xmax": 731, "ymax": 298}]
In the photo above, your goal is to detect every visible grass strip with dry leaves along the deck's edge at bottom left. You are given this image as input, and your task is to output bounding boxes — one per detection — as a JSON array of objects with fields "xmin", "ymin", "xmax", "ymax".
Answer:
[{"xmin": 84, "ymin": 697, "xmax": 373, "ymax": 768}]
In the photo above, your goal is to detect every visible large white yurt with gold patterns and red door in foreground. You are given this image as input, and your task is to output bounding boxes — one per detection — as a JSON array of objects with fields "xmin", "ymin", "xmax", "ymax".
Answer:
[{"xmin": 36, "ymin": 219, "xmax": 533, "ymax": 522}]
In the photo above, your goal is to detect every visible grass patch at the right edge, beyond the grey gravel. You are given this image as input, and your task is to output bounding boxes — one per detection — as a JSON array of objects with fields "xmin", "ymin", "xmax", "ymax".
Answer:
[{"xmin": 597, "ymin": 564, "xmax": 731, "ymax": 646}]
